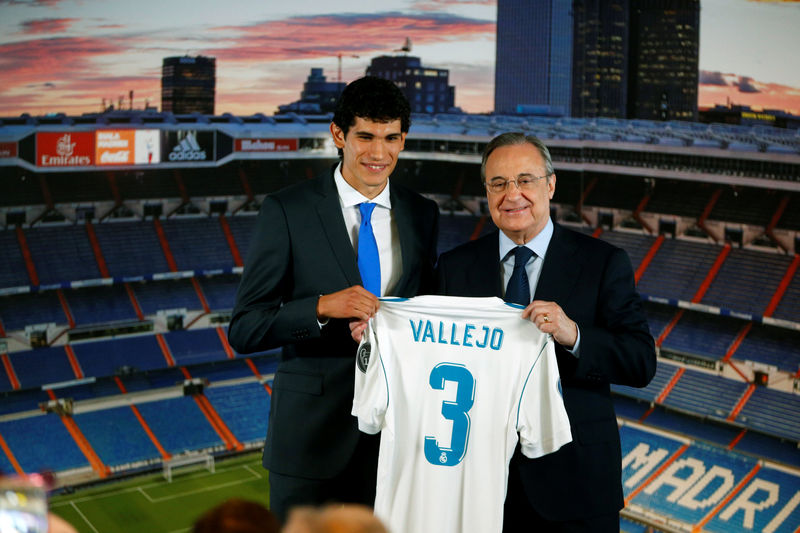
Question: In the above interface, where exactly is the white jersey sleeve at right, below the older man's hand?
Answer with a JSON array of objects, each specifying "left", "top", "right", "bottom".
[{"left": 517, "top": 337, "right": 572, "bottom": 459}]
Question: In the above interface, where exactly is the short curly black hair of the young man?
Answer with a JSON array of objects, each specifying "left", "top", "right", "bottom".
[{"left": 333, "top": 76, "right": 411, "bottom": 135}]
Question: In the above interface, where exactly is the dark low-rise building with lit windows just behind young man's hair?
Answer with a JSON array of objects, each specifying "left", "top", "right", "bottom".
[{"left": 367, "top": 55, "right": 456, "bottom": 113}]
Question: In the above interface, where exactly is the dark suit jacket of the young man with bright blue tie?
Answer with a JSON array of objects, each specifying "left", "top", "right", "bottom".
[{"left": 228, "top": 168, "right": 439, "bottom": 479}]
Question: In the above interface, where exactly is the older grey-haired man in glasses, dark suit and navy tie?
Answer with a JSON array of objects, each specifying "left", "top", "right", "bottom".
[{"left": 437, "top": 133, "right": 656, "bottom": 533}]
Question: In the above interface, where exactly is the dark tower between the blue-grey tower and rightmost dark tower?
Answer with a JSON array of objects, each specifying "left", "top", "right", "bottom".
[{"left": 572, "top": 0, "right": 630, "bottom": 118}]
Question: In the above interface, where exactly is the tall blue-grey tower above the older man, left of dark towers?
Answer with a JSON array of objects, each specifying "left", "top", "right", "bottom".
[{"left": 494, "top": 0, "right": 573, "bottom": 115}]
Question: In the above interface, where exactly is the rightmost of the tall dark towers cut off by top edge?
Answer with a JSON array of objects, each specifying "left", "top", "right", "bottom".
[{"left": 628, "top": 0, "right": 700, "bottom": 121}]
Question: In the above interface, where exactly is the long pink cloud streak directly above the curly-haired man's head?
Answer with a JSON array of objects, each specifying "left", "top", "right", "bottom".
[{"left": 203, "top": 12, "right": 495, "bottom": 62}]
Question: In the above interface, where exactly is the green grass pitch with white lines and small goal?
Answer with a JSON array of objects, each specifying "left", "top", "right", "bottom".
[{"left": 50, "top": 453, "right": 269, "bottom": 533}]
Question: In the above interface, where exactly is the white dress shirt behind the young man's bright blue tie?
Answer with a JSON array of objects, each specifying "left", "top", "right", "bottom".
[{"left": 333, "top": 163, "right": 403, "bottom": 296}]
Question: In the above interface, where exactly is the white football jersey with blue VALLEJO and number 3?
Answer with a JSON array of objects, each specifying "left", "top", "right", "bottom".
[{"left": 352, "top": 296, "right": 572, "bottom": 533}]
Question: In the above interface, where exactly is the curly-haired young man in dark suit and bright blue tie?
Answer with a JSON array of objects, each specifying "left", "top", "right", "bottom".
[{"left": 228, "top": 77, "right": 439, "bottom": 521}]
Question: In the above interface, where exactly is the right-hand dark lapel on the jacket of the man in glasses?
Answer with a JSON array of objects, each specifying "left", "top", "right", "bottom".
[{"left": 534, "top": 224, "right": 581, "bottom": 302}]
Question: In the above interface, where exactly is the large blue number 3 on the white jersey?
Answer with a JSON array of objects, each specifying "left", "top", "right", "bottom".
[{"left": 425, "top": 363, "right": 475, "bottom": 466}]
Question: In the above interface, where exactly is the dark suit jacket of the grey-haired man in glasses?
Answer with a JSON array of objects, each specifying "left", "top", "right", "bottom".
[{"left": 437, "top": 224, "right": 656, "bottom": 521}]
